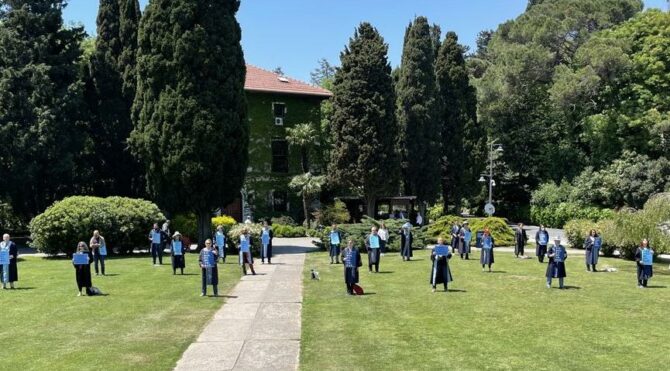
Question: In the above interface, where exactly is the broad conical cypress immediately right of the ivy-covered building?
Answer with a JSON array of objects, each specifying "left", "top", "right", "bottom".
[{"left": 329, "top": 23, "right": 399, "bottom": 216}]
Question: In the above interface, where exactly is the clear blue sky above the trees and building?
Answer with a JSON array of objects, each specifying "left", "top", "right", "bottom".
[{"left": 63, "top": 0, "right": 667, "bottom": 81}]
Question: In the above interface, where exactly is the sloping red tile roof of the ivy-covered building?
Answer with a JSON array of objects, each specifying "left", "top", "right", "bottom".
[{"left": 244, "top": 64, "right": 333, "bottom": 98}]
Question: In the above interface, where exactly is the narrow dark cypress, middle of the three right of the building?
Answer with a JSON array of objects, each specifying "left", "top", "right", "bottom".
[{"left": 396, "top": 17, "right": 440, "bottom": 214}]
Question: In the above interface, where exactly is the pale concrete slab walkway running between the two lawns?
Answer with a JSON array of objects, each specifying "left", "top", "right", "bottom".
[{"left": 175, "top": 238, "right": 313, "bottom": 370}]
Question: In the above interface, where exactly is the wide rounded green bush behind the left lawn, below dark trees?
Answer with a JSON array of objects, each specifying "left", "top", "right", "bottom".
[{"left": 29, "top": 196, "right": 165, "bottom": 255}]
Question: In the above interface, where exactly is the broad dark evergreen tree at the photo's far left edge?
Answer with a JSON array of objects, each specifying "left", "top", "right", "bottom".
[{"left": 0, "top": 0, "right": 88, "bottom": 217}]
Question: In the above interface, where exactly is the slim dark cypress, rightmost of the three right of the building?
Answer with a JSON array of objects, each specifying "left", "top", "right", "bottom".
[{"left": 435, "top": 32, "right": 486, "bottom": 214}]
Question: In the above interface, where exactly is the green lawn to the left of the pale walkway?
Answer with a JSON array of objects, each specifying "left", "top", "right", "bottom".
[{"left": 0, "top": 254, "right": 240, "bottom": 370}]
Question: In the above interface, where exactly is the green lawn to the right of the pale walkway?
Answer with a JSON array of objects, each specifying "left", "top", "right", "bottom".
[{"left": 300, "top": 251, "right": 670, "bottom": 370}]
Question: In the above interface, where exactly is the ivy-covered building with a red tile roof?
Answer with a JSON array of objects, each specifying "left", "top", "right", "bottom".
[{"left": 224, "top": 65, "right": 332, "bottom": 221}]
